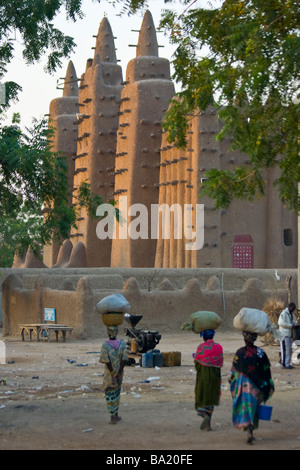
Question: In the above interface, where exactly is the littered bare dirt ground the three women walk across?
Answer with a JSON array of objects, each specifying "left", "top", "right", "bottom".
[{"left": 0, "top": 329, "right": 300, "bottom": 453}]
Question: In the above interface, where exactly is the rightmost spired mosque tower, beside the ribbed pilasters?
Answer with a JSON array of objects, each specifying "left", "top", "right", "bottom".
[{"left": 112, "top": 11, "right": 175, "bottom": 267}]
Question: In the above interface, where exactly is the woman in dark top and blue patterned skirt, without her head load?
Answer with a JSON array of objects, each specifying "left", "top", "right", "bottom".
[{"left": 229, "top": 331, "right": 274, "bottom": 444}]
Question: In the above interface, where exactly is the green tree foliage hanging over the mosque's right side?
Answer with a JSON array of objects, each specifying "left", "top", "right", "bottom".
[{"left": 121, "top": 0, "right": 300, "bottom": 212}]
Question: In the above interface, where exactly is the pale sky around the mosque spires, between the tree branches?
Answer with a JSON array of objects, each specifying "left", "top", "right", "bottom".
[{"left": 3, "top": 0, "right": 188, "bottom": 127}]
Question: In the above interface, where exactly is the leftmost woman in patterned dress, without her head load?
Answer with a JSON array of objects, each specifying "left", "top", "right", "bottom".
[{"left": 100, "top": 326, "right": 128, "bottom": 424}]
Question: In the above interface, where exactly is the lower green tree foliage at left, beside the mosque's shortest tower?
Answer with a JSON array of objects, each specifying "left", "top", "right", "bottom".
[{"left": 0, "top": 115, "right": 103, "bottom": 266}]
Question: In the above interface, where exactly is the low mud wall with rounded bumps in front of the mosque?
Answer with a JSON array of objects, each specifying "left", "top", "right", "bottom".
[{"left": 0, "top": 268, "right": 297, "bottom": 339}]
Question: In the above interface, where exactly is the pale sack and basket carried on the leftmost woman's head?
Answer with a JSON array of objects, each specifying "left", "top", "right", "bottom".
[{"left": 96, "top": 294, "right": 130, "bottom": 326}]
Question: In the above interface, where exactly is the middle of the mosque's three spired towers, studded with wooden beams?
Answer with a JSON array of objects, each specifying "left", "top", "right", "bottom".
[{"left": 71, "top": 17, "right": 123, "bottom": 267}]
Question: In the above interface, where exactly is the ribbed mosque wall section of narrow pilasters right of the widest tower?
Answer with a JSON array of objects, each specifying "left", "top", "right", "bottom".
[{"left": 155, "top": 104, "right": 198, "bottom": 268}]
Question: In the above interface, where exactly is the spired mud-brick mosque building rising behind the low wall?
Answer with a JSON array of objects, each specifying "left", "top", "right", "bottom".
[{"left": 14, "top": 11, "right": 297, "bottom": 269}]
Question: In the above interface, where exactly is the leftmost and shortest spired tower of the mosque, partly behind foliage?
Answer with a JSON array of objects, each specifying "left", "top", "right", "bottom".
[{"left": 43, "top": 61, "right": 79, "bottom": 267}]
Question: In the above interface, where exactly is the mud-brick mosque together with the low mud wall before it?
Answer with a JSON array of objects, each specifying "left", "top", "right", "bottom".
[{"left": 0, "top": 11, "right": 297, "bottom": 339}]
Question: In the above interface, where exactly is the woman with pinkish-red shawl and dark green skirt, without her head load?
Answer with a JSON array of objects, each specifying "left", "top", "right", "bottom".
[{"left": 194, "top": 330, "right": 223, "bottom": 431}]
